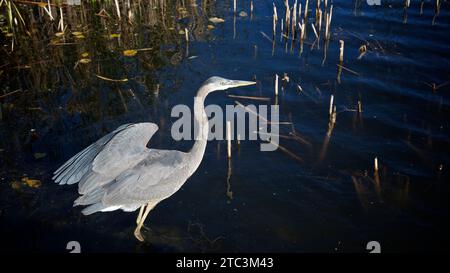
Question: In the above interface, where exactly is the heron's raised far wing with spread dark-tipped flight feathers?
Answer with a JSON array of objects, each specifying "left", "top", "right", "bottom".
[{"left": 53, "top": 123, "right": 158, "bottom": 193}]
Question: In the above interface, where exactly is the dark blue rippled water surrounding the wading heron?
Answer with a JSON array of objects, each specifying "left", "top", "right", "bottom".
[{"left": 0, "top": 1, "right": 450, "bottom": 252}]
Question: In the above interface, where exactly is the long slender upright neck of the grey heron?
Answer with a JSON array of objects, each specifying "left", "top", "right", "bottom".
[{"left": 189, "top": 87, "right": 209, "bottom": 174}]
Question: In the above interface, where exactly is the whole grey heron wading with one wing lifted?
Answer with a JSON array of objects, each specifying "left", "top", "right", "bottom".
[{"left": 53, "top": 77, "right": 255, "bottom": 241}]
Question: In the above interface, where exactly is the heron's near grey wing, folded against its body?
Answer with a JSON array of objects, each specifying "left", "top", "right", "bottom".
[{"left": 102, "top": 149, "right": 189, "bottom": 206}]
